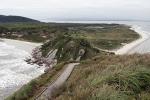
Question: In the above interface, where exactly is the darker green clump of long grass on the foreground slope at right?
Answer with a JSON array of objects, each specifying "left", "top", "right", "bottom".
[{"left": 107, "top": 68, "right": 150, "bottom": 94}]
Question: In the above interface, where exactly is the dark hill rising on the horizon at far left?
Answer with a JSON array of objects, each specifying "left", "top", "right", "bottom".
[{"left": 0, "top": 15, "right": 39, "bottom": 23}]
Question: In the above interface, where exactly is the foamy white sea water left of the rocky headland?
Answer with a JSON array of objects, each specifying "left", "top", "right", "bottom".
[{"left": 0, "top": 42, "right": 44, "bottom": 100}]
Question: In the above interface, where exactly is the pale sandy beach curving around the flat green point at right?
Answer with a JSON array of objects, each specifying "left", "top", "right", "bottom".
[{"left": 114, "top": 25, "right": 150, "bottom": 55}]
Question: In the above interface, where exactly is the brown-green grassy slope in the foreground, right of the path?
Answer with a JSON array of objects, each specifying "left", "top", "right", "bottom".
[{"left": 56, "top": 55, "right": 150, "bottom": 100}]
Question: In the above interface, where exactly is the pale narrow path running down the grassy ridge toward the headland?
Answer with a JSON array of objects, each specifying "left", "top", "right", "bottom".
[{"left": 36, "top": 63, "right": 79, "bottom": 100}]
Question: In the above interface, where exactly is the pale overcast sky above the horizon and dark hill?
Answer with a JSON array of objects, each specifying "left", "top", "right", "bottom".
[{"left": 0, "top": 0, "right": 150, "bottom": 21}]
